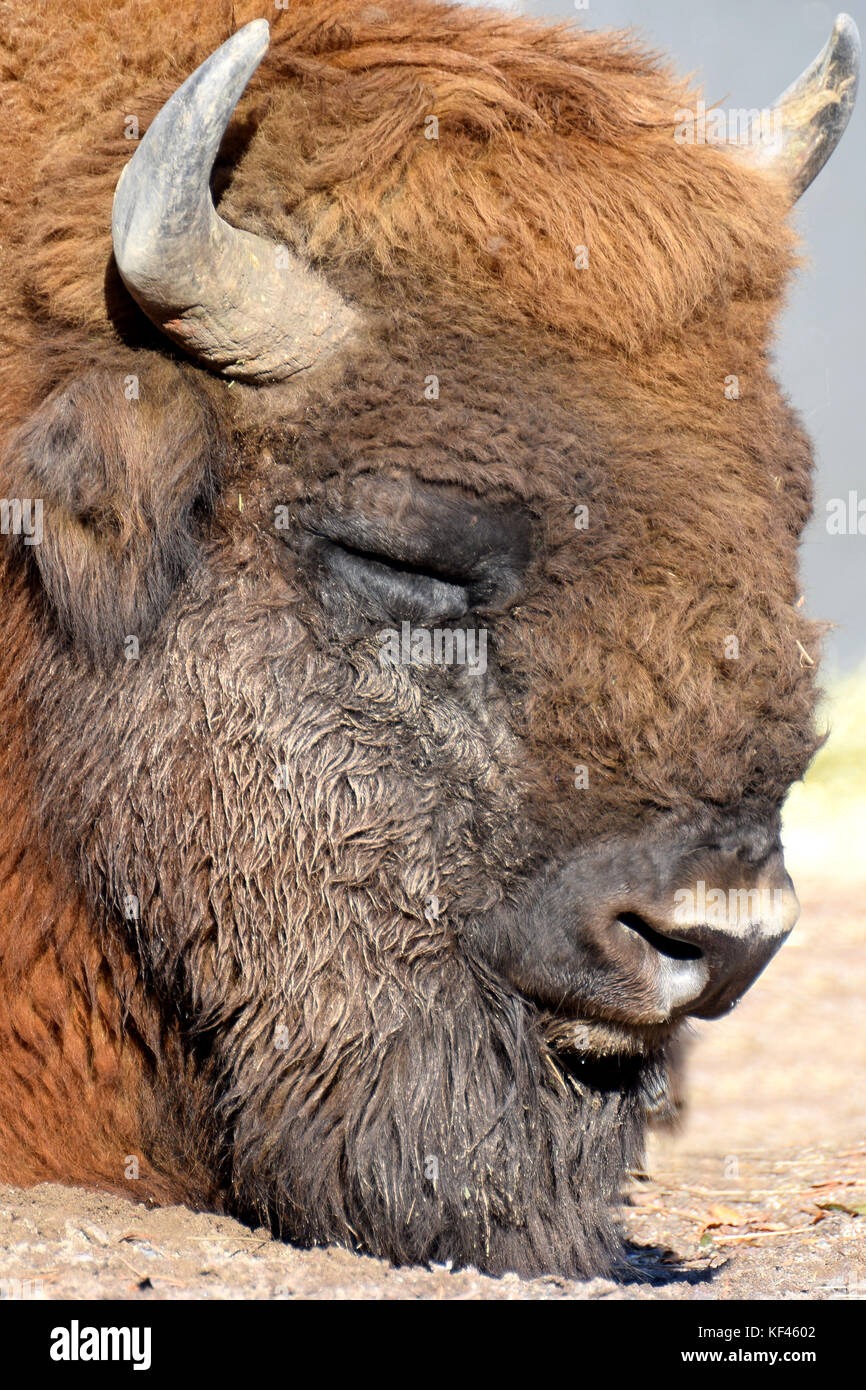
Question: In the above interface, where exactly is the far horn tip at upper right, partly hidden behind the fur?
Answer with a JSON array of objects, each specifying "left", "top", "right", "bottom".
[{"left": 742, "top": 14, "right": 860, "bottom": 203}]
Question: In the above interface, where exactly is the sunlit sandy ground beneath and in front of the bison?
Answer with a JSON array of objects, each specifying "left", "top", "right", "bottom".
[{"left": 0, "top": 885, "right": 866, "bottom": 1300}]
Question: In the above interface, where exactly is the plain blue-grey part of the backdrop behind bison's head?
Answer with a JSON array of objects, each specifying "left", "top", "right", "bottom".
[{"left": 487, "top": 0, "right": 866, "bottom": 676}]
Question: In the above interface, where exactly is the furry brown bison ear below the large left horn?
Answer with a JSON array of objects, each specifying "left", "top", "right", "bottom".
[{"left": 6, "top": 360, "right": 225, "bottom": 663}]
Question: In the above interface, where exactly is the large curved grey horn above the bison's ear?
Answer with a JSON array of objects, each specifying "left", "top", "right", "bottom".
[{"left": 111, "top": 19, "right": 354, "bottom": 381}]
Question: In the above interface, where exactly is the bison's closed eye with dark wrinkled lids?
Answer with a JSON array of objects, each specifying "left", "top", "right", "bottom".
[{"left": 299, "top": 474, "right": 530, "bottom": 626}]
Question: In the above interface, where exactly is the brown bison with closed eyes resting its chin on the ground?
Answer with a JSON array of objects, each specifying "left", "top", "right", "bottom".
[{"left": 0, "top": 0, "right": 859, "bottom": 1275}]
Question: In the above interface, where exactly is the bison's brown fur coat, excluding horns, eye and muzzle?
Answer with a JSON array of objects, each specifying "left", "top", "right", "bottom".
[{"left": 0, "top": 0, "right": 816, "bottom": 1269}]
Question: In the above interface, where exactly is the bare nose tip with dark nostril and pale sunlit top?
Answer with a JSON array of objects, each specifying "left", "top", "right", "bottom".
[{"left": 612, "top": 865, "right": 799, "bottom": 1019}]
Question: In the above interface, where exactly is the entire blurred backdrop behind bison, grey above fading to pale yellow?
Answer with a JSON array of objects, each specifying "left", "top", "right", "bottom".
[{"left": 475, "top": 0, "right": 866, "bottom": 889}]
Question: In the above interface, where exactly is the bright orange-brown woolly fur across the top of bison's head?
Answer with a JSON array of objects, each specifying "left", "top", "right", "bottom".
[{"left": 0, "top": 0, "right": 791, "bottom": 414}]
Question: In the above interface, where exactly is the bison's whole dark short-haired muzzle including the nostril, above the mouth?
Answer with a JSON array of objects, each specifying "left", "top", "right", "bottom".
[{"left": 463, "top": 820, "right": 799, "bottom": 1027}]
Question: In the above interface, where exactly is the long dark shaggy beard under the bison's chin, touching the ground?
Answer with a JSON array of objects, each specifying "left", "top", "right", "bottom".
[{"left": 221, "top": 956, "right": 666, "bottom": 1277}]
